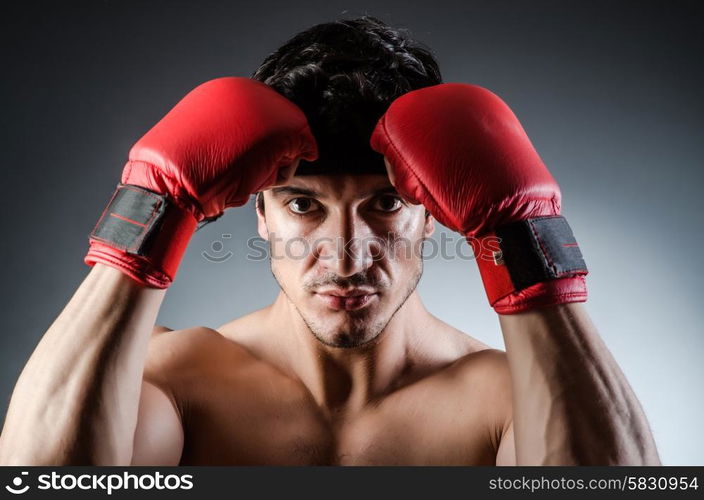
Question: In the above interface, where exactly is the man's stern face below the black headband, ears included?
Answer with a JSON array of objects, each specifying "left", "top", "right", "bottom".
[{"left": 258, "top": 175, "right": 434, "bottom": 347}]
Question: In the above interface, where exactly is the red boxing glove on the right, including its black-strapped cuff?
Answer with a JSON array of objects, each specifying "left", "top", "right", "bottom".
[{"left": 371, "top": 83, "right": 587, "bottom": 314}]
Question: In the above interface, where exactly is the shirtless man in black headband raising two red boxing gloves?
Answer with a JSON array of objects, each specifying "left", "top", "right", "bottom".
[{"left": 0, "top": 17, "right": 659, "bottom": 465}]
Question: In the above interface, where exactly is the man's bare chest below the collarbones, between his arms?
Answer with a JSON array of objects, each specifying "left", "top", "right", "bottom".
[{"left": 175, "top": 372, "right": 496, "bottom": 465}]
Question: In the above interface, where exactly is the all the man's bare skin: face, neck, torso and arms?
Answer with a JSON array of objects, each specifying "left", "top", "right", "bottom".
[{"left": 0, "top": 175, "right": 659, "bottom": 465}]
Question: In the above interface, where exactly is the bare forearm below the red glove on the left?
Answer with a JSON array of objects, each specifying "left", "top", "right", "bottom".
[{"left": 0, "top": 264, "right": 165, "bottom": 465}]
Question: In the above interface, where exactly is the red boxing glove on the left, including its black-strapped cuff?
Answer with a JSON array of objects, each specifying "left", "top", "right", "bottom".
[{"left": 85, "top": 77, "right": 318, "bottom": 288}]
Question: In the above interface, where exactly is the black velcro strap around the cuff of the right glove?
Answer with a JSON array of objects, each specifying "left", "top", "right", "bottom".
[{"left": 495, "top": 216, "right": 587, "bottom": 290}]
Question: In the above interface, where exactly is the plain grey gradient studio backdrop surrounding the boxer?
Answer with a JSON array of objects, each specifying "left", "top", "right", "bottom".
[{"left": 0, "top": 0, "right": 704, "bottom": 465}]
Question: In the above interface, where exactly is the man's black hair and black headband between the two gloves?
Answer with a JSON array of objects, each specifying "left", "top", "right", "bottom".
[{"left": 252, "top": 16, "right": 442, "bottom": 184}]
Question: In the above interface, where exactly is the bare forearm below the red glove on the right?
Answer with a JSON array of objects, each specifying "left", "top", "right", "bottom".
[{"left": 499, "top": 303, "right": 659, "bottom": 465}]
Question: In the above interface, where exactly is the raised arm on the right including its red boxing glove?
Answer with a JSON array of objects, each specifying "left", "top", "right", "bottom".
[{"left": 371, "top": 83, "right": 658, "bottom": 465}]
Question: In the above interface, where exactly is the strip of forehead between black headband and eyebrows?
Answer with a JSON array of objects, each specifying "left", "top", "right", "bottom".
[{"left": 270, "top": 174, "right": 395, "bottom": 199}]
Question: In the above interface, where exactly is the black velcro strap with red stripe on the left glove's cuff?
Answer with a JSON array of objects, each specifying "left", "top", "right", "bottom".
[{"left": 90, "top": 184, "right": 169, "bottom": 255}]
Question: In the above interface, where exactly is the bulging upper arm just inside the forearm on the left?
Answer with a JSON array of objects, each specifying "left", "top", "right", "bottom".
[{"left": 132, "top": 381, "right": 183, "bottom": 465}]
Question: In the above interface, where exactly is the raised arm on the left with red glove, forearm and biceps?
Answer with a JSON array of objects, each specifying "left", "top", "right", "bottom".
[{"left": 0, "top": 77, "right": 317, "bottom": 465}]
